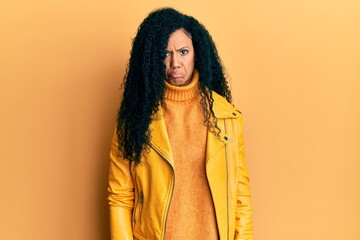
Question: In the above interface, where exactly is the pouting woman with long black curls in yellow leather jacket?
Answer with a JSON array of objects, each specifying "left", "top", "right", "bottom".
[{"left": 108, "top": 8, "right": 253, "bottom": 240}]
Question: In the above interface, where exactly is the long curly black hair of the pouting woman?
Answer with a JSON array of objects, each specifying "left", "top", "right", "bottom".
[{"left": 116, "top": 8, "right": 231, "bottom": 164}]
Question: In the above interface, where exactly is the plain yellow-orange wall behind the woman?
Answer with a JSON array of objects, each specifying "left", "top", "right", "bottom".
[{"left": 0, "top": 0, "right": 360, "bottom": 240}]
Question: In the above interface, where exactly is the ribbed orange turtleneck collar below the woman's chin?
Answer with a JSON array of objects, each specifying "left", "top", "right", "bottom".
[{"left": 164, "top": 69, "right": 200, "bottom": 104}]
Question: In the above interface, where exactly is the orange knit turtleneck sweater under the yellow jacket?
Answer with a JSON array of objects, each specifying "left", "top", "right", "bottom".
[{"left": 162, "top": 71, "right": 218, "bottom": 240}]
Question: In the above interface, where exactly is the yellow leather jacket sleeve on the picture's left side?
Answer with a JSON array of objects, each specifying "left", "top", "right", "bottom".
[{"left": 108, "top": 128, "right": 134, "bottom": 240}]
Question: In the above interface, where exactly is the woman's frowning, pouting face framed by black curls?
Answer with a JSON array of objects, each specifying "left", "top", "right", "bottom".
[{"left": 165, "top": 29, "right": 195, "bottom": 86}]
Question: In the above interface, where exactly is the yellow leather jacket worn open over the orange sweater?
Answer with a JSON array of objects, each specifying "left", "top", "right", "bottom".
[{"left": 108, "top": 92, "right": 253, "bottom": 240}]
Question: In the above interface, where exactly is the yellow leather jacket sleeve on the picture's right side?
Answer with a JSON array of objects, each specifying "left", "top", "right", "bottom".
[{"left": 235, "top": 116, "right": 254, "bottom": 240}]
